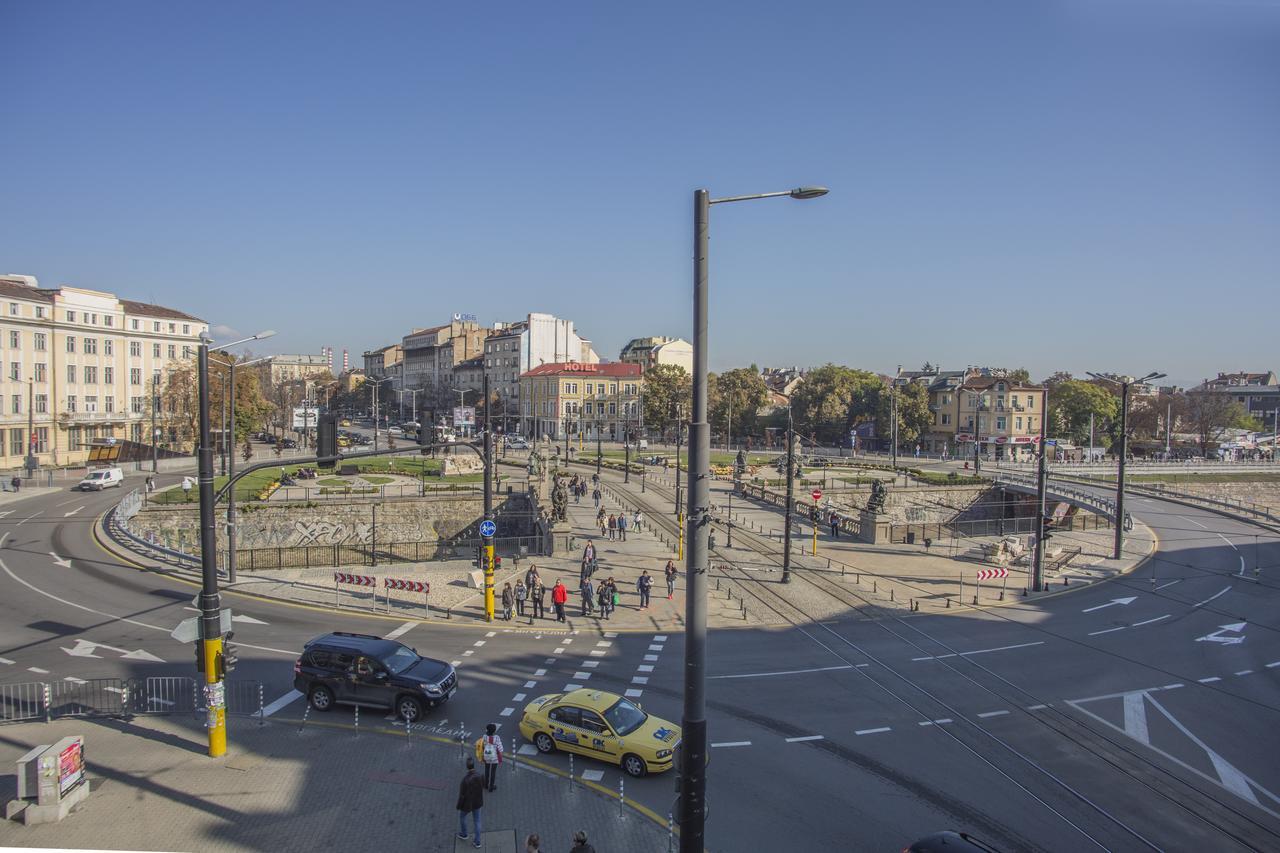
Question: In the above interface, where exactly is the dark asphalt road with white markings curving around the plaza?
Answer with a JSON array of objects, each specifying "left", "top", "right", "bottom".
[{"left": 0, "top": 468, "right": 1280, "bottom": 850}]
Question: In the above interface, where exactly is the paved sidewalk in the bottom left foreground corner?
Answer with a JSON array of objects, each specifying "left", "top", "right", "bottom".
[{"left": 0, "top": 716, "right": 668, "bottom": 853}]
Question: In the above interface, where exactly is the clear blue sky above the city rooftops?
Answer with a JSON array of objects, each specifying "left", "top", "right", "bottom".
[{"left": 0, "top": 0, "right": 1280, "bottom": 383}]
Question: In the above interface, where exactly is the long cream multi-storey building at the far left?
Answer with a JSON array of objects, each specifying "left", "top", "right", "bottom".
[{"left": 0, "top": 274, "right": 209, "bottom": 469}]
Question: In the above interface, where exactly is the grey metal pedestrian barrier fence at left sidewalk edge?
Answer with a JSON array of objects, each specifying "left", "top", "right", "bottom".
[{"left": 0, "top": 676, "right": 262, "bottom": 724}]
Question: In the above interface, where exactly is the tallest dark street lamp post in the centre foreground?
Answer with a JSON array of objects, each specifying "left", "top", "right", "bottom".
[{"left": 676, "top": 187, "right": 827, "bottom": 853}]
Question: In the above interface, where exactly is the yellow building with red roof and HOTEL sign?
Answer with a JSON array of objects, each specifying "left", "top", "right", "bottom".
[{"left": 520, "top": 361, "right": 644, "bottom": 441}]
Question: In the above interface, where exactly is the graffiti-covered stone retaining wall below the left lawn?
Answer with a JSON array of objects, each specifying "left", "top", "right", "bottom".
[{"left": 131, "top": 493, "right": 535, "bottom": 552}]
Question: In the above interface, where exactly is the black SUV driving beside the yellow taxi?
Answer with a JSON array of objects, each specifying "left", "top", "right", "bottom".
[{"left": 293, "top": 631, "right": 458, "bottom": 722}]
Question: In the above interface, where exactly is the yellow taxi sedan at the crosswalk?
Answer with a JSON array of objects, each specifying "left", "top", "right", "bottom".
[{"left": 520, "top": 689, "right": 681, "bottom": 776}]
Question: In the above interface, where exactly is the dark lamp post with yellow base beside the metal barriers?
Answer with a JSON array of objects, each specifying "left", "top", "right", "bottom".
[{"left": 197, "top": 332, "right": 275, "bottom": 758}]
